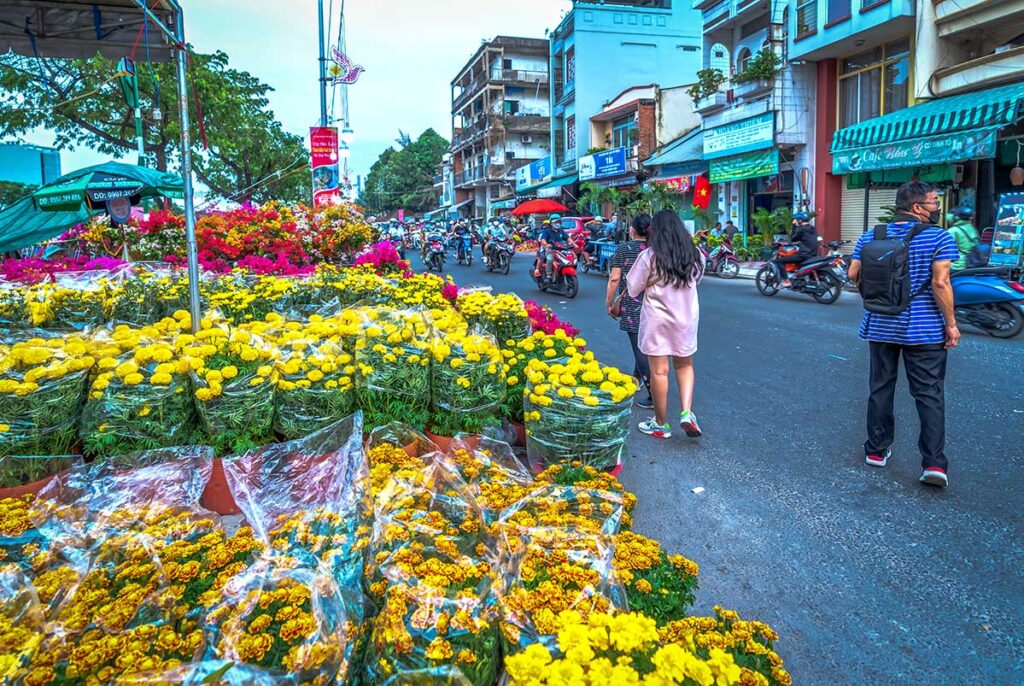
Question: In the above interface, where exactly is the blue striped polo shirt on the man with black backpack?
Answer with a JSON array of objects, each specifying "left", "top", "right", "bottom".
[{"left": 853, "top": 221, "right": 959, "bottom": 345}]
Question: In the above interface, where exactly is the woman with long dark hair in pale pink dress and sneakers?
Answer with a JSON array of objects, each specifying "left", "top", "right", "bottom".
[{"left": 627, "top": 210, "right": 703, "bottom": 438}]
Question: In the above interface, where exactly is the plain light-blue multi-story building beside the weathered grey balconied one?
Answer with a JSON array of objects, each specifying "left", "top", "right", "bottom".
[{"left": 551, "top": 0, "right": 700, "bottom": 189}]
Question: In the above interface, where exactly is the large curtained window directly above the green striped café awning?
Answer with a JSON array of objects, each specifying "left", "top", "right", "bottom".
[{"left": 839, "top": 39, "right": 910, "bottom": 127}]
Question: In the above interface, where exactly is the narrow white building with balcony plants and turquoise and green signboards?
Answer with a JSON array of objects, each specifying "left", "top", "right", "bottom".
[{"left": 693, "top": 0, "right": 814, "bottom": 232}]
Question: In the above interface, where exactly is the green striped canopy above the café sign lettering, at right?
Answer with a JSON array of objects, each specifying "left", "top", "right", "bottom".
[{"left": 831, "top": 83, "right": 1024, "bottom": 153}]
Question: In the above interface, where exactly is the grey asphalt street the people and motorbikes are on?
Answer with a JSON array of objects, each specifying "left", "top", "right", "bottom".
[{"left": 416, "top": 247, "right": 1024, "bottom": 684}]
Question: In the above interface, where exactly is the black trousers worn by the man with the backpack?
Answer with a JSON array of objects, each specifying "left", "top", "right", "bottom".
[{"left": 864, "top": 341, "right": 948, "bottom": 469}]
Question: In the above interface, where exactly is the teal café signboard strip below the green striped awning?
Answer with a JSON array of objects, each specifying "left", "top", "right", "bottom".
[{"left": 833, "top": 129, "right": 996, "bottom": 174}]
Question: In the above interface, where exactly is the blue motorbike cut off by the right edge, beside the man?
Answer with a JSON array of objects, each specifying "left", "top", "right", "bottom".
[{"left": 951, "top": 267, "right": 1024, "bottom": 338}]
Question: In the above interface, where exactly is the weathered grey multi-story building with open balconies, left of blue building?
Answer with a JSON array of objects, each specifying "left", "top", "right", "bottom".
[{"left": 452, "top": 36, "right": 551, "bottom": 217}]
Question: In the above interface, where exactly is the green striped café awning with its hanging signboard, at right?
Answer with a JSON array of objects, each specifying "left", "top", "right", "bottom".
[{"left": 831, "top": 84, "right": 1024, "bottom": 174}]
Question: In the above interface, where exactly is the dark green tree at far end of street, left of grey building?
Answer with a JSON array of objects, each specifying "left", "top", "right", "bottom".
[{"left": 359, "top": 129, "right": 449, "bottom": 214}]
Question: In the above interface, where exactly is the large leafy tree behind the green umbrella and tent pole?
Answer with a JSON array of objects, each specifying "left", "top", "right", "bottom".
[{"left": 0, "top": 50, "right": 309, "bottom": 202}]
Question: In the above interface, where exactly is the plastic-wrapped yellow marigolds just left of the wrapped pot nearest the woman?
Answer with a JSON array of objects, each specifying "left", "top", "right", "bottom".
[{"left": 430, "top": 329, "right": 505, "bottom": 436}]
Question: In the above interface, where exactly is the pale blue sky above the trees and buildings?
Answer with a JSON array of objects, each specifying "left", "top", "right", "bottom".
[{"left": 18, "top": 0, "right": 571, "bottom": 198}]
